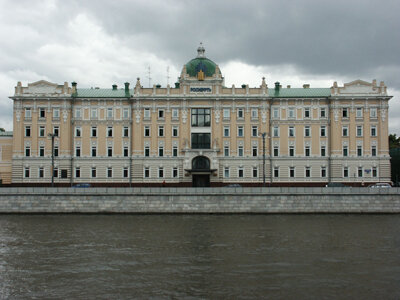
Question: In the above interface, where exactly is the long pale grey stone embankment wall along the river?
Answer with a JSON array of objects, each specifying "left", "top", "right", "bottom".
[{"left": 0, "top": 187, "right": 400, "bottom": 213}]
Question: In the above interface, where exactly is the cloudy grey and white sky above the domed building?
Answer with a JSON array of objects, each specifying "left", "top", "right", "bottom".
[{"left": 0, "top": 0, "right": 400, "bottom": 135}]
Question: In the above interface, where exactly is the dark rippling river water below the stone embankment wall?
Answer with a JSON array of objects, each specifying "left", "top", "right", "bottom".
[{"left": 0, "top": 215, "right": 400, "bottom": 299}]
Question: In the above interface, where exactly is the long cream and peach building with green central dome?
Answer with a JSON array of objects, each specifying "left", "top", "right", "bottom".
[{"left": 0, "top": 46, "right": 391, "bottom": 186}]
